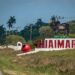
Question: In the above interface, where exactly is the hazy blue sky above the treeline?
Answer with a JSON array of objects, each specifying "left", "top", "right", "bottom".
[{"left": 0, "top": 0, "right": 75, "bottom": 29}]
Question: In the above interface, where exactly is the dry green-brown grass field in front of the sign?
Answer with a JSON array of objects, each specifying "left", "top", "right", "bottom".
[{"left": 0, "top": 49, "right": 75, "bottom": 75}]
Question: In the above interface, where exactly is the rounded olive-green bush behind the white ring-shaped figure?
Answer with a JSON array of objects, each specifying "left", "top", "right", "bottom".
[{"left": 6, "top": 35, "right": 26, "bottom": 45}]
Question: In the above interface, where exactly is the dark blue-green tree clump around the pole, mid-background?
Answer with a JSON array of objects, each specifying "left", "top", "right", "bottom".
[{"left": 20, "top": 19, "right": 48, "bottom": 41}]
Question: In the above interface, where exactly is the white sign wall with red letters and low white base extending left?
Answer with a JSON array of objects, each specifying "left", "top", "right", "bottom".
[{"left": 17, "top": 38, "right": 75, "bottom": 56}]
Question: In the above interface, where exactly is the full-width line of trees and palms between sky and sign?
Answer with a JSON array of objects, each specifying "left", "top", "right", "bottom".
[{"left": 0, "top": 16, "right": 75, "bottom": 45}]
